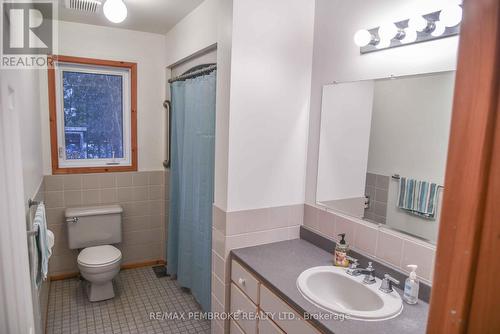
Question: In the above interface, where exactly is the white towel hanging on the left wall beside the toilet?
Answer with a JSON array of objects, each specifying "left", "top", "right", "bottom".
[{"left": 33, "top": 203, "right": 54, "bottom": 284}]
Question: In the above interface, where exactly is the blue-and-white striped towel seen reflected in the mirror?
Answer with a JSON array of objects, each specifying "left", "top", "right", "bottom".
[{"left": 398, "top": 177, "right": 438, "bottom": 219}]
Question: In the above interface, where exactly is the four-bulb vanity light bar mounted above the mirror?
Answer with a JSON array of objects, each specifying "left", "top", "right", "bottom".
[{"left": 354, "top": 4, "right": 462, "bottom": 54}]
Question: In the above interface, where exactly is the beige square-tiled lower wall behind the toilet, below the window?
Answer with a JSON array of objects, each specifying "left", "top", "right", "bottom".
[{"left": 44, "top": 171, "right": 169, "bottom": 275}]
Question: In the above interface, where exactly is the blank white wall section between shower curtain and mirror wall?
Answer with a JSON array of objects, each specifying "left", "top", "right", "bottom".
[{"left": 227, "top": 0, "right": 314, "bottom": 211}]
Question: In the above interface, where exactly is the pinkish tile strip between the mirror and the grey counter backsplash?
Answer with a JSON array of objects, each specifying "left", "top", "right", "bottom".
[{"left": 304, "top": 205, "right": 436, "bottom": 285}]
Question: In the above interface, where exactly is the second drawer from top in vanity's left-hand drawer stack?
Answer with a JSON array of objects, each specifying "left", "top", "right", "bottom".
[{"left": 231, "top": 283, "right": 257, "bottom": 334}]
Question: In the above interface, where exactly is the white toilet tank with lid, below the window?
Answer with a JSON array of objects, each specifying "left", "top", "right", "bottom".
[{"left": 66, "top": 205, "right": 123, "bottom": 249}]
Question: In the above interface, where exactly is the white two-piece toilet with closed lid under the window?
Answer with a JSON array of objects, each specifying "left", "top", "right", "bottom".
[{"left": 65, "top": 205, "right": 123, "bottom": 302}]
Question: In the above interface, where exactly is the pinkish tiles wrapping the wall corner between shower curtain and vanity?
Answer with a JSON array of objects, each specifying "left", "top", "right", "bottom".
[{"left": 212, "top": 204, "right": 304, "bottom": 333}]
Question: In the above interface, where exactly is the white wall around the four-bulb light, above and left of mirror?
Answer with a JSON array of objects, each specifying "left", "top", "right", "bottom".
[{"left": 306, "top": 0, "right": 458, "bottom": 204}]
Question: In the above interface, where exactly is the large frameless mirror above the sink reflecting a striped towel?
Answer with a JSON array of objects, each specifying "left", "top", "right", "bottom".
[{"left": 316, "top": 72, "right": 455, "bottom": 243}]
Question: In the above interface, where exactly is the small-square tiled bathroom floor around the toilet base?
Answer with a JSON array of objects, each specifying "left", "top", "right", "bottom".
[{"left": 47, "top": 267, "right": 210, "bottom": 334}]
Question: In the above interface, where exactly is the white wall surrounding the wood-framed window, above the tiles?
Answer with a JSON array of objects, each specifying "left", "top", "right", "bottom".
[{"left": 40, "top": 22, "right": 166, "bottom": 174}]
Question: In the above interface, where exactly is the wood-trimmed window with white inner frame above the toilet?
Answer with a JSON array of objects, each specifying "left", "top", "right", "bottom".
[{"left": 49, "top": 56, "right": 137, "bottom": 174}]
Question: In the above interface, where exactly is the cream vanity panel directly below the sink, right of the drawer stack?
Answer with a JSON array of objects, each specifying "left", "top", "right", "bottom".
[{"left": 260, "top": 285, "right": 320, "bottom": 334}]
